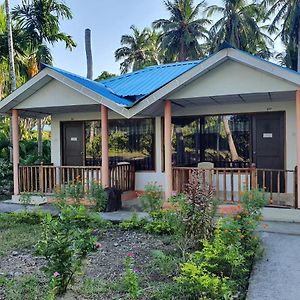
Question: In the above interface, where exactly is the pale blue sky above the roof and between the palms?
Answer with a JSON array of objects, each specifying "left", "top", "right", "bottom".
[{"left": 11, "top": 0, "right": 282, "bottom": 78}]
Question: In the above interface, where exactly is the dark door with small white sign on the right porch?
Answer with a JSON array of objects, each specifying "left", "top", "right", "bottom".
[{"left": 253, "top": 113, "right": 284, "bottom": 192}]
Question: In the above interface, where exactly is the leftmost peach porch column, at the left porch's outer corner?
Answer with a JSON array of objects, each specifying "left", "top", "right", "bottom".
[{"left": 11, "top": 109, "right": 20, "bottom": 195}]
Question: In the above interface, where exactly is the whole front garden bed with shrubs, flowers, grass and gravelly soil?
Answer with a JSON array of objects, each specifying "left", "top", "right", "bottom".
[{"left": 0, "top": 173, "right": 265, "bottom": 300}]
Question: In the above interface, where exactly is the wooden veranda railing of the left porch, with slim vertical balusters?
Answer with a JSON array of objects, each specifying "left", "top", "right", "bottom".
[{"left": 19, "top": 164, "right": 135, "bottom": 194}]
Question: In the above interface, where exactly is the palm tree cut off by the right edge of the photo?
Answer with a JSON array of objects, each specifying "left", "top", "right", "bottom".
[{"left": 262, "top": 0, "right": 300, "bottom": 72}]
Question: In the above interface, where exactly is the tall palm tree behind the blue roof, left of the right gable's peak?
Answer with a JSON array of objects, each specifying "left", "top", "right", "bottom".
[{"left": 153, "top": 0, "right": 210, "bottom": 61}]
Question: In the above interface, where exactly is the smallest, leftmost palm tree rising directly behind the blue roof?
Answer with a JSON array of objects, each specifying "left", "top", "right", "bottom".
[{"left": 115, "top": 25, "right": 157, "bottom": 74}]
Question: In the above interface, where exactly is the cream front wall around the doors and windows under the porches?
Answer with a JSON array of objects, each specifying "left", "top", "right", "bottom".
[{"left": 51, "top": 101, "right": 296, "bottom": 190}]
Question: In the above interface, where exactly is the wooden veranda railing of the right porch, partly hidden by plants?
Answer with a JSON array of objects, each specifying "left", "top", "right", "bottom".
[{"left": 173, "top": 166, "right": 297, "bottom": 207}]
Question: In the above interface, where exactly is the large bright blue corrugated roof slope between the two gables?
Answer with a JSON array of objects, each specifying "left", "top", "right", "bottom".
[{"left": 101, "top": 60, "right": 201, "bottom": 99}]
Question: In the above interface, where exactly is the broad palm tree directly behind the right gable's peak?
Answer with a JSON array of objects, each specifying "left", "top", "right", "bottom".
[{"left": 206, "top": 0, "right": 272, "bottom": 58}]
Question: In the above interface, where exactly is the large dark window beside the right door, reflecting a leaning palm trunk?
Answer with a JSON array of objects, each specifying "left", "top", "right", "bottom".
[{"left": 172, "top": 114, "right": 250, "bottom": 167}]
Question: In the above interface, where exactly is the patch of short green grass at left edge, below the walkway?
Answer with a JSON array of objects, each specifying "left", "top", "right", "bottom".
[{"left": 0, "top": 214, "right": 41, "bottom": 257}]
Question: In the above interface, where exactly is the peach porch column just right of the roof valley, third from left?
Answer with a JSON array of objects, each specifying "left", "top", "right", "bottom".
[{"left": 165, "top": 100, "right": 173, "bottom": 200}]
